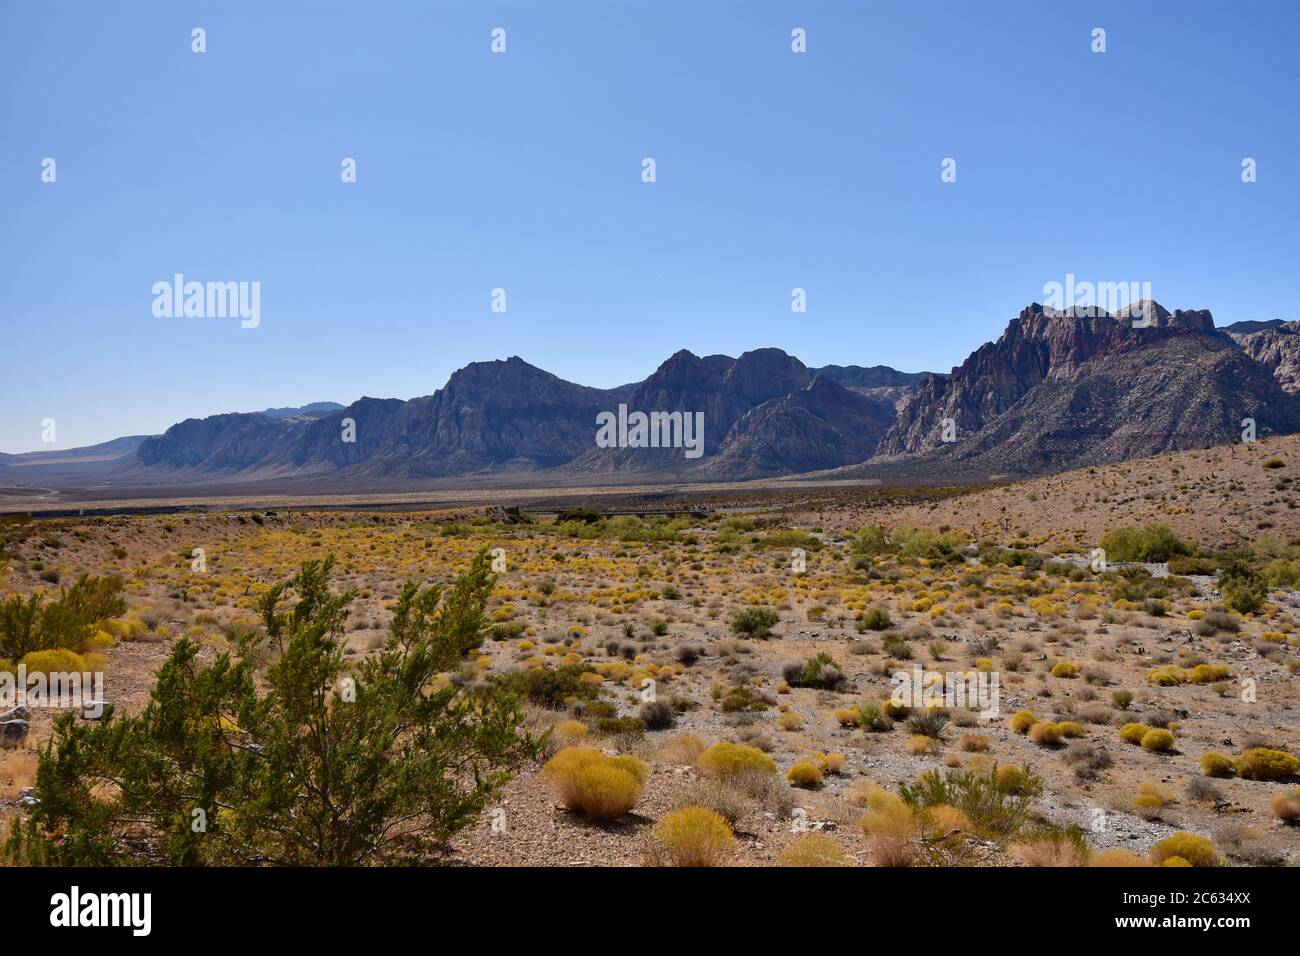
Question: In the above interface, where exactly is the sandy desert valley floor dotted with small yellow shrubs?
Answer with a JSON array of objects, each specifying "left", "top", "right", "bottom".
[{"left": 0, "top": 436, "right": 1300, "bottom": 866}]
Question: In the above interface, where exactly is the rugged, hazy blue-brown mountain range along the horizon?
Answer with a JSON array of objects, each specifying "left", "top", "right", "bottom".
[{"left": 10, "top": 302, "right": 1300, "bottom": 494}]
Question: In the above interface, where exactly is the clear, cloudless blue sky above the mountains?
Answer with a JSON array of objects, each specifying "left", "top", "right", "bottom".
[{"left": 0, "top": 0, "right": 1300, "bottom": 451}]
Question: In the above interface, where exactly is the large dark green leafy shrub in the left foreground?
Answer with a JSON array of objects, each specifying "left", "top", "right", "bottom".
[{"left": 8, "top": 553, "right": 538, "bottom": 866}]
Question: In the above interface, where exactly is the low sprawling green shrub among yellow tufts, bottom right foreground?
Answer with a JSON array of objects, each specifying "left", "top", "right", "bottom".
[{"left": 898, "top": 767, "right": 1043, "bottom": 839}]
